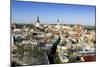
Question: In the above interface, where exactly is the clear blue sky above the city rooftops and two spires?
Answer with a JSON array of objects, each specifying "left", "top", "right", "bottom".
[{"left": 12, "top": 0, "right": 96, "bottom": 25}]
